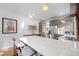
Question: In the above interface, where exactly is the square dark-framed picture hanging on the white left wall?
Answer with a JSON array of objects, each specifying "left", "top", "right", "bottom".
[{"left": 2, "top": 18, "right": 17, "bottom": 34}]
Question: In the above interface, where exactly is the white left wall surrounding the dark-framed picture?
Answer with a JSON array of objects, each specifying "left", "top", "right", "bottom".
[{"left": 0, "top": 13, "right": 26, "bottom": 49}]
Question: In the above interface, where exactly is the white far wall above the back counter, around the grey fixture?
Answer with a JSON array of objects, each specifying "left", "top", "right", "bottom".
[{"left": 23, "top": 18, "right": 39, "bottom": 35}]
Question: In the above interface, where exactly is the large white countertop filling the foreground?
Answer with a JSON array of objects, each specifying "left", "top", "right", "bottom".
[{"left": 20, "top": 36, "right": 79, "bottom": 56}]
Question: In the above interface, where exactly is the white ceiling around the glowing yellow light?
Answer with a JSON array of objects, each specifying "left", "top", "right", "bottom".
[{"left": 0, "top": 3, "right": 70, "bottom": 19}]
